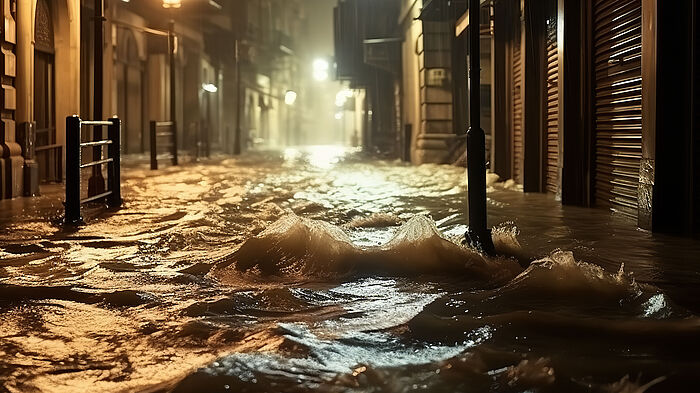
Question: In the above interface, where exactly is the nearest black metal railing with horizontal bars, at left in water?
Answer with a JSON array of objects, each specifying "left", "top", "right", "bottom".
[{"left": 65, "top": 116, "right": 122, "bottom": 225}]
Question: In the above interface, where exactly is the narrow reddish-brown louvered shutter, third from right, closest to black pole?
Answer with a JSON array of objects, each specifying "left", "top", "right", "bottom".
[{"left": 511, "top": 28, "right": 523, "bottom": 184}]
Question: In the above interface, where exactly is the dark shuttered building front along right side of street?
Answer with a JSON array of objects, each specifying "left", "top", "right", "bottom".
[{"left": 486, "top": 0, "right": 699, "bottom": 232}]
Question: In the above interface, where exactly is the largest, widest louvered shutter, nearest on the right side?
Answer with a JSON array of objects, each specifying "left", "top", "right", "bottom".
[{"left": 593, "top": 0, "right": 642, "bottom": 217}]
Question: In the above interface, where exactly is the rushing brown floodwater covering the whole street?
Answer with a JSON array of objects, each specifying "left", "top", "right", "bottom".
[{"left": 0, "top": 147, "right": 700, "bottom": 392}]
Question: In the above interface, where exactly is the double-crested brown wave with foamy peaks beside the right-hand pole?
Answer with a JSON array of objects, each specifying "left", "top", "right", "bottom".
[{"left": 212, "top": 214, "right": 520, "bottom": 282}]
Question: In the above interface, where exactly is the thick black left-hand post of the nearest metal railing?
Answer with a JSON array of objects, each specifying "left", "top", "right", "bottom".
[{"left": 65, "top": 116, "right": 83, "bottom": 225}]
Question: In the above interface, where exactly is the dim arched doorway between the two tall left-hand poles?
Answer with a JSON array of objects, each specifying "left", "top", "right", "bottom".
[{"left": 114, "top": 29, "right": 146, "bottom": 153}]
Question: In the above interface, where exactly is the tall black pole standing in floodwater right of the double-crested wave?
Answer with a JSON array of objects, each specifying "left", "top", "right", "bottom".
[{"left": 465, "top": 0, "right": 494, "bottom": 254}]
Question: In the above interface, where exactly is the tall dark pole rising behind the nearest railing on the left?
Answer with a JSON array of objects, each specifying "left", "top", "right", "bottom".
[{"left": 88, "top": 0, "right": 105, "bottom": 196}]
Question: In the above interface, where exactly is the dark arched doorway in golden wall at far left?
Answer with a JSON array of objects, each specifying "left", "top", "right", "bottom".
[{"left": 34, "top": 0, "right": 63, "bottom": 182}]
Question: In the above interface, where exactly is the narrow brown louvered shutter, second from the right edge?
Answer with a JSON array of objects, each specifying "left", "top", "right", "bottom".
[{"left": 543, "top": 19, "right": 559, "bottom": 194}]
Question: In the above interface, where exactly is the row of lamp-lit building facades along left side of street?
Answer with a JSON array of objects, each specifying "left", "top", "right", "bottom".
[{"left": 0, "top": 0, "right": 312, "bottom": 198}]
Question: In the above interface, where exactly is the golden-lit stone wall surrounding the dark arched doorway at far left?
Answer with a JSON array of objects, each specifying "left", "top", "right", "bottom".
[{"left": 0, "top": 0, "right": 80, "bottom": 198}]
